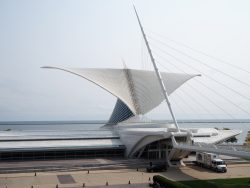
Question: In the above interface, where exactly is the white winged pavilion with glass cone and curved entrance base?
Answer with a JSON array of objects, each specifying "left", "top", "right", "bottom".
[{"left": 43, "top": 67, "right": 246, "bottom": 160}]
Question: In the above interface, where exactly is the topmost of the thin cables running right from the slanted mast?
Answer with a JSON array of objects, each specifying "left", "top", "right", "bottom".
[{"left": 146, "top": 28, "right": 250, "bottom": 74}]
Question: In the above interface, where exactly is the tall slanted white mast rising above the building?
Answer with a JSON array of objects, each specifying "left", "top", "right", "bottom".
[{"left": 133, "top": 5, "right": 180, "bottom": 132}]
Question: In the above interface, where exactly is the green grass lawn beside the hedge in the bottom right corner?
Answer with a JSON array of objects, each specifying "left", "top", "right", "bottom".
[{"left": 180, "top": 177, "right": 250, "bottom": 188}]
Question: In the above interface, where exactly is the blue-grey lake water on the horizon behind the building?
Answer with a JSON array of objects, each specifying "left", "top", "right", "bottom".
[{"left": 0, "top": 120, "right": 250, "bottom": 144}]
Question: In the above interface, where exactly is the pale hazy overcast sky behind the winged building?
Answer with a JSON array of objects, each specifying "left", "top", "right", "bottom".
[{"left": 0, "top": 0, "right": 250, "bottom": 121}]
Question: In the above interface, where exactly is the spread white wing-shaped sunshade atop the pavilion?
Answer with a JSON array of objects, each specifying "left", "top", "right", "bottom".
[{"left": 43, "top": 67, "right": 197, "bottom": 114}]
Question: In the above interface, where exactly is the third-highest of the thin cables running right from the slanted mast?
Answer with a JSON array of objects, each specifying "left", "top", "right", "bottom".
[{"left": 151, "top": 44, "right": 250, "bottom": 101}]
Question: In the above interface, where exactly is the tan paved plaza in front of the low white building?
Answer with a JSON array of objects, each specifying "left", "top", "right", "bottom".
[{"left": 0, "top": 164, "right": 250, "bottom": 188}]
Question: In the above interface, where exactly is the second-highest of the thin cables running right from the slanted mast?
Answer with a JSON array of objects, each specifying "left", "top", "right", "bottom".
[{"left": 149, "top": 36, "right": 250, "bottom": 87}]
